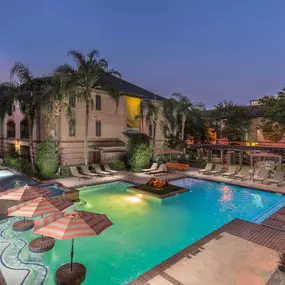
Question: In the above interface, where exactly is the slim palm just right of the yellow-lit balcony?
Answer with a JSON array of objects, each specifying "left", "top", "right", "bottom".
[{"left": 141, "top": 100, "right": 162, "bottom": 156}]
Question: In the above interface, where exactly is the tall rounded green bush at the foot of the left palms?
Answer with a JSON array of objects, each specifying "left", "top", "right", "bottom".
[{"left": 36, "top": 137, "right": 59, "bottom": 178}]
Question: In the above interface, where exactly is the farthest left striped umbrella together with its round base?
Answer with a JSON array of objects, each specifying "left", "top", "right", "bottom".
[{"left": 0, "top": 185, "right": 52, "bottom": 231}]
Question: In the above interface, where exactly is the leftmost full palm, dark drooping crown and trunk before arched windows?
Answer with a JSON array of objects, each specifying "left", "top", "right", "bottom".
[{"left": 9, "top": 62, "right": 41, "bottom": 172}]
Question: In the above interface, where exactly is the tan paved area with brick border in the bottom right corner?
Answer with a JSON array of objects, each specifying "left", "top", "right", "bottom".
[{"left": 129, "top": 201, "right": 285, "bottom": 285}]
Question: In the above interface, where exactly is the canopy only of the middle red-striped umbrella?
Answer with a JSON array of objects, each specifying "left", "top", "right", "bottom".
[{"left": 8, "top": 197, "right": 72, "bottom": 218}]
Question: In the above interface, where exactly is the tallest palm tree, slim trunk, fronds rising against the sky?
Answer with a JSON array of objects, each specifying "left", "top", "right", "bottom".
[{"left": 56, "top": 50, "right": 120, "bottom": 165}]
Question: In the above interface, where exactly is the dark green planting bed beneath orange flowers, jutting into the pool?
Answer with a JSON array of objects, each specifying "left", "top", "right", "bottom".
[{"left": 128, "top": 184, "right": 189, "bottom": 199}]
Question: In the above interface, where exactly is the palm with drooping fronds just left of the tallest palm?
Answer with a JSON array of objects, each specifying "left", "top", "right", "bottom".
[{"left": 42, "top": 74, "right": 74, "bottom": 147}]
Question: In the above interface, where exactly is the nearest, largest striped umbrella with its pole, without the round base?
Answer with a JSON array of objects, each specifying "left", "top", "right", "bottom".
[{"left": 34, "top": 210, "right": 113, "bottom": 271}]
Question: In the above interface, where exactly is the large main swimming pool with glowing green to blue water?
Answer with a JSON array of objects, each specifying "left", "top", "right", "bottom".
[{"left": 0, "top": 179, "right": 285, "bottom": 285}]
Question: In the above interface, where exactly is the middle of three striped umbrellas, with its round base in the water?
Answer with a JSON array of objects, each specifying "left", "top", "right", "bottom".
[{"left": 8, "top": 197, "right": 73, "bottom": 252}]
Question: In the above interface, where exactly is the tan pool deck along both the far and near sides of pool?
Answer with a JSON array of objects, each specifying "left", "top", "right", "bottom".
[{"left": 0, "top": 168, "right": 285, "bottom": 285}]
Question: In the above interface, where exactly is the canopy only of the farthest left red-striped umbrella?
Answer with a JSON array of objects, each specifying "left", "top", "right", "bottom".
[{"left": 0, "top": 185, "right": 52, "bottom": 202}]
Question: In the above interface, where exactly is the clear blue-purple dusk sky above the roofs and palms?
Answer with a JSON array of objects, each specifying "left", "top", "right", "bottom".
[{"left": 0, "top": 0, "right": 285, "bottom": 106}]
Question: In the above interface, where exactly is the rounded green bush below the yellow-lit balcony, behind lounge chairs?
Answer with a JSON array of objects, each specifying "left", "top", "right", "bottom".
[{"left": 129, "top": 143, "right": 152, "bottom": 172}]
